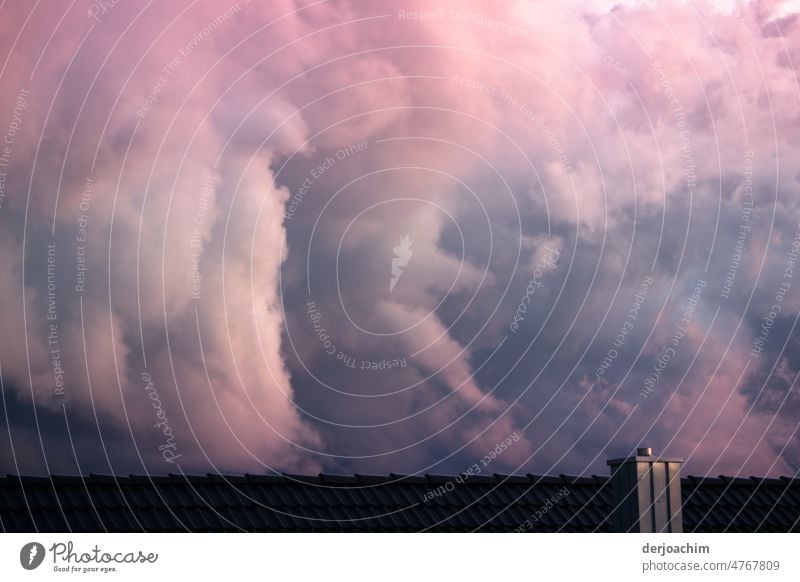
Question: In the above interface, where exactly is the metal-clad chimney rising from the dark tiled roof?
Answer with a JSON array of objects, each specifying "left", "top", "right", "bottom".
[{"left": 607, "top": 447, "right": 683, "bottom": 533}]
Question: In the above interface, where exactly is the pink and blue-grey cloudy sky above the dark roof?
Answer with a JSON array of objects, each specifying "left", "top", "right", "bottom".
[{"left": 0, "top": 0, "right": 800, "bottom": 476}]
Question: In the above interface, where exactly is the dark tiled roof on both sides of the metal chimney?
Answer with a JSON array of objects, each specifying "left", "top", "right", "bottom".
[{"left": 0, "top": 474, "right": 800, "bottom": 532}]
